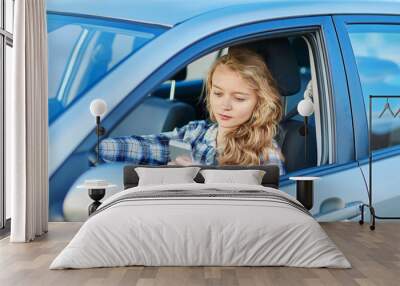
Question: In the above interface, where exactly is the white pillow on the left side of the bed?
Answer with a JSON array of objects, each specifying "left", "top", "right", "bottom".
[{"left": 135, "top": 167, "right": 200, "bottom": 186}]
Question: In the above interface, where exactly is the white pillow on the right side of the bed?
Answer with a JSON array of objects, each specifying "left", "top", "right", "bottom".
[{"left": 200, "top": 169, "right": 265, "bottom": 185}]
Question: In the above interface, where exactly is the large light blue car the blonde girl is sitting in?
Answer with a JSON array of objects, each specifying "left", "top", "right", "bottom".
[{"left": 47, "top": 0, "right": 400, "bottom": 221}]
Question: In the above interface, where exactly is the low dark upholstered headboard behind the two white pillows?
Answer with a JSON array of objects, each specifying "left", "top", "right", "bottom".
[{"left": 124, "top": 165, "right": 279, "bottom": 189}]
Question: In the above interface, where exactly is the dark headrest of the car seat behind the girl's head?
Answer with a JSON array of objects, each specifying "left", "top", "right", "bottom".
[{"left": 234, "top": 38, "right": 301, "bottom": 96}]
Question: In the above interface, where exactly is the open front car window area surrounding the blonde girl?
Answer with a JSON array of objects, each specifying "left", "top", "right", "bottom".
[{"left": 110, "top": 35, "right": 327, "bottom": 173}]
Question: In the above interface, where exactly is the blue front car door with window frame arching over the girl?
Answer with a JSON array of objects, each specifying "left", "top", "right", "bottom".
[{"left": 97, "top": 16, "right": 367, "bottom": 220}]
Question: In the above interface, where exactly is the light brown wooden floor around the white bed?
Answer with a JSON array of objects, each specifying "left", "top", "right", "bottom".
[{"left": 0, "top": 222, "right": 400, "bottom": 286}]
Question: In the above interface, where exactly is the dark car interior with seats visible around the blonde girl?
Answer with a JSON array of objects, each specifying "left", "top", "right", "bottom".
[{"left": 108, "top": 36, "right": 318, "bottom": 172}]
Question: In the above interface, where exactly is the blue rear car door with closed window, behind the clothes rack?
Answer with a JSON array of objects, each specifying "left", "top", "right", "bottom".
[{"left": 334, "top": 15, "right": 400, "bottom": 217}]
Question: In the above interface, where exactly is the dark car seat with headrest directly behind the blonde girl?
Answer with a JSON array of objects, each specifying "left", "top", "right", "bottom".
[{"left": 234, "top": 38, "right": 317, "bottom": 172}]
